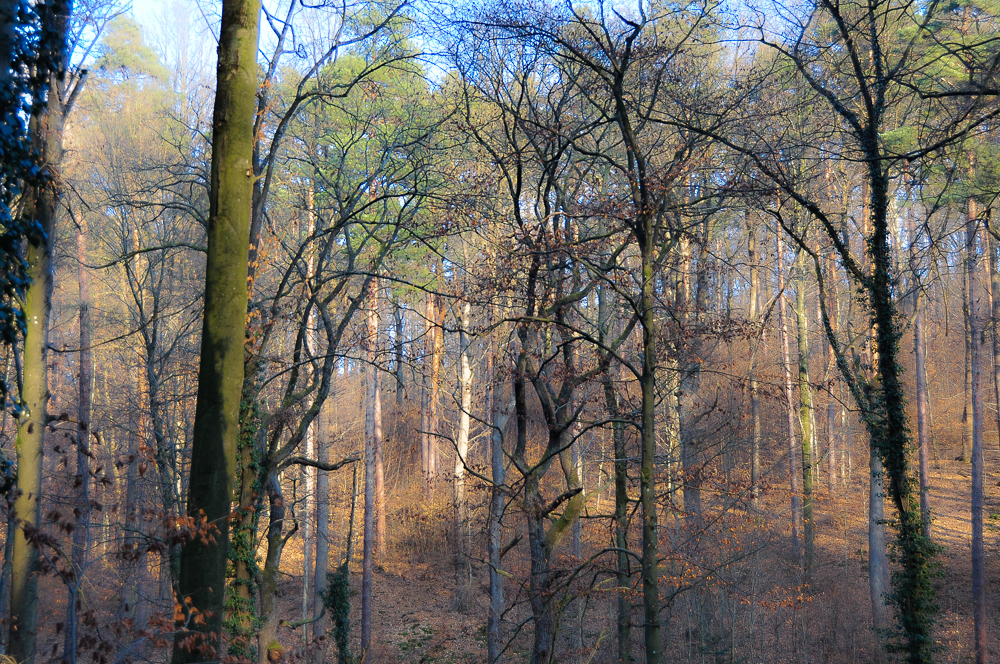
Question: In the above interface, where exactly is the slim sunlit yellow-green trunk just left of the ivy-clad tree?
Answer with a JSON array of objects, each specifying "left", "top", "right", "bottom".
[{"left": 795, "top": 253, "right": 816, "bottom": 573}]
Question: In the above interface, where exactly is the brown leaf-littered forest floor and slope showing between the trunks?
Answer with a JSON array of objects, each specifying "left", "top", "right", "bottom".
[{"left": 13, "top": 440, "right": 1000, "bottom": 664}]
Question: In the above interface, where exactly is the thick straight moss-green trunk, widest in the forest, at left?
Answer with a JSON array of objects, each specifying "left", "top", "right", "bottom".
[{"left": 173, "top": 0, "right": 260, "bottom": 664}]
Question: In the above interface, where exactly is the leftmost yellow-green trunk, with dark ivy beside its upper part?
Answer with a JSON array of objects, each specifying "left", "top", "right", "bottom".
[{"left": 7, "top": 0, "right": 73, "bottom": 664}]
